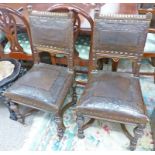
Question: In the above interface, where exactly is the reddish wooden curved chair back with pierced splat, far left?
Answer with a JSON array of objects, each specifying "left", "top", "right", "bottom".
[{"left": 0, "top": 5, "right": 33, "bottom": 60}]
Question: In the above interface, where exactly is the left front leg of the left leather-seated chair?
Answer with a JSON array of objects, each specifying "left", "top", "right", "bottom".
[{"left": 9, "top": 101, "right": 24, "bottom": 124}]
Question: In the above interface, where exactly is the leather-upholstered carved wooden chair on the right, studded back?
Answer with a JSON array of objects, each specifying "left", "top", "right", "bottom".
[{"left": 76, "top": 12, "right": 151, "bottom": 150}]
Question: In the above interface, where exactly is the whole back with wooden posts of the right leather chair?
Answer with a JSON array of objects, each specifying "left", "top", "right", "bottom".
[{"left": 90, "top": 11, "right": 151, "bottom": 76}]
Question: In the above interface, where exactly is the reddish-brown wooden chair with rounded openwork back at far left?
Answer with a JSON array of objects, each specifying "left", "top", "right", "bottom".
[{"left": 0, "top": 5, "right": 33, "bottom": 61}]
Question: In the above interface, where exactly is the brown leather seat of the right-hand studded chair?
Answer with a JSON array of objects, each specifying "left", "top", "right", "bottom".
[{"left": 77, "top": 71, "right": 148, "bottom": 123}]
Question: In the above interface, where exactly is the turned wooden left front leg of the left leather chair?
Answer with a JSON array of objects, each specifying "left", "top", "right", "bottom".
[{"left": 10, "top": 101, "right": 24, "bottom": 124}]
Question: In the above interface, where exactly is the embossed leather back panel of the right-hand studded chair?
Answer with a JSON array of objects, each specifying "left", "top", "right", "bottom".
[{"left": 93, "top": 15, "right": 150, "bottom": 58}]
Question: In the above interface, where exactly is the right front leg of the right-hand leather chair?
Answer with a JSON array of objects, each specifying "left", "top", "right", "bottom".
[{"left": 130, "top": 124, "right": 145, "bottom": 151}]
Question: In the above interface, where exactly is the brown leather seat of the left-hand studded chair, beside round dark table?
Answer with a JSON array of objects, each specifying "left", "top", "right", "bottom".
[{"left": 5, "top": 63, "right": 73, "bottom": 112}]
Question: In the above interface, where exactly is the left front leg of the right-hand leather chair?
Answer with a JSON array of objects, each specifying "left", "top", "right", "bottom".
[{"left": 77, "top": 115, "right": 85, "bottom": 139}]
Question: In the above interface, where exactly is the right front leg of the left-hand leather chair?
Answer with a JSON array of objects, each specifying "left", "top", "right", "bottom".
[{"left": 55, "top": 115, "right": 65, "bottom": 140}]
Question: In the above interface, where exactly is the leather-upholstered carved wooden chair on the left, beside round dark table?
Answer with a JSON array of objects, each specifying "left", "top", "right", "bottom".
[{"left": 5, "top": 7, "right": 75, "bottom": 138}]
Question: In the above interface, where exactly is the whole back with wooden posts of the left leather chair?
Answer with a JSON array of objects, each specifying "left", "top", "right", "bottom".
[{"left": 28, "top": 7, "right": 74, "bottom": 71}]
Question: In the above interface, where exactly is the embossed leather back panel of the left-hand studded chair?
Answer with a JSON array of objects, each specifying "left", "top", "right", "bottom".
[{"left": 29, "top": 11, "right": 73, "bottom": 50}]
